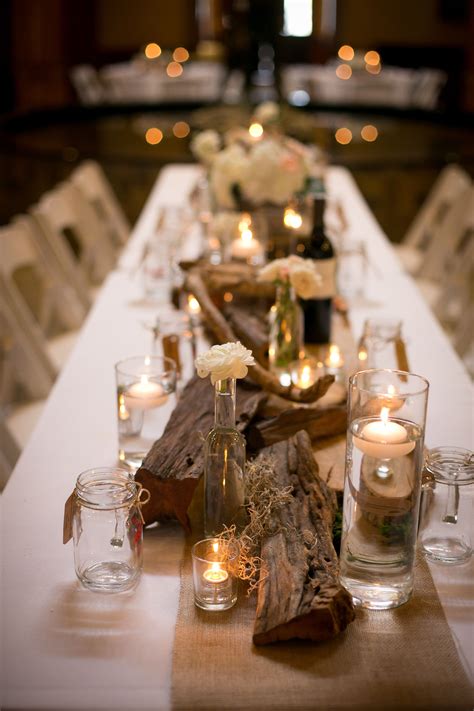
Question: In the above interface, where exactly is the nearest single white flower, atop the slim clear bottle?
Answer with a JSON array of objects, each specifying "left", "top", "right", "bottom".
[{"left": 194, "top": 341, "right": 255, "bottom": 385}]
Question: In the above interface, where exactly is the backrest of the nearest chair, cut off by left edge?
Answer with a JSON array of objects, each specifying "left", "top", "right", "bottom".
[{"left": 0, "top": 274, "right": 56, "bottom": 406}]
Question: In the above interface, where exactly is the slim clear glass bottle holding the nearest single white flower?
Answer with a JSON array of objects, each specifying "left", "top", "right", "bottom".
[{"left": 204, "top": 378, "right": 245, "bottom": 537}]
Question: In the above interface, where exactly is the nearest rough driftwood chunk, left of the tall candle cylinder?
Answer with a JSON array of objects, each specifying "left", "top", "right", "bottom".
[{"left": 253, "top": 432, "right": 354, "bottom": 645}]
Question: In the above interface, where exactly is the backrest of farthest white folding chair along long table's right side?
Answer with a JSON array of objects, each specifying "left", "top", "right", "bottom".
[{"left": 403, "top": 163, "right": 471, "bottom": 249}]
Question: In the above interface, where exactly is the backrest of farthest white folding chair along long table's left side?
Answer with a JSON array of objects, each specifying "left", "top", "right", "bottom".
[{"left": 70, "top": 160, "right": 130, "bottom": 247}]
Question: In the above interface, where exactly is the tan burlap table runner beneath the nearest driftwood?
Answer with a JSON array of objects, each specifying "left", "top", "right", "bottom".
[{"left": 172, "top": 548, "right": 474, "bottom": 711}]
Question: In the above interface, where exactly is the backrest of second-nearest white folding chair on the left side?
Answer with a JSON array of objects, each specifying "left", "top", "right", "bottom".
[{"left": 0, "top": 216, "right": 87, "bottom": 337}]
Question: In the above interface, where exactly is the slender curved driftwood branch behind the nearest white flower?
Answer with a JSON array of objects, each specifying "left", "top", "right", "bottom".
[{"left": 185, "top": 269, "right": 334, "bottom": 402}]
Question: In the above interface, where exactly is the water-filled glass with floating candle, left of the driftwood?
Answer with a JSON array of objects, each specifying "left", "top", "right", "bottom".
[{"left": 115, "top": 355, "right": 176, "bottom": 470}]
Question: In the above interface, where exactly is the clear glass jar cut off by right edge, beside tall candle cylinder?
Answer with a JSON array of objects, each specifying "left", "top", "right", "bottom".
[{"left": 419, "top": 447, "right": 474, "bottom": 565}]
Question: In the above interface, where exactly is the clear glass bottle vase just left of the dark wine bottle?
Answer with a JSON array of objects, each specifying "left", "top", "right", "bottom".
[{"left": 268, "top": 279, "right": 303, "bottom": 385}]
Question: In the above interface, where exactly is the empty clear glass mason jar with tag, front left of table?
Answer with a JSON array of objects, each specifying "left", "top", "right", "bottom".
[{"left": 72, "top": 468, "right": 149, "bottom": 592}]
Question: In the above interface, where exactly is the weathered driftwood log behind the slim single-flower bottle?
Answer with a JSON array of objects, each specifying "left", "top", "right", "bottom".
[{"left": 135, "top": 376, "right": 267, "bottom": 532}]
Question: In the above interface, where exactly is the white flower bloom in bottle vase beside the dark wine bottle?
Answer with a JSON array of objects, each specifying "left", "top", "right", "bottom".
[{"left": 258, "top": 255, "right": 323, "bottom": 299}]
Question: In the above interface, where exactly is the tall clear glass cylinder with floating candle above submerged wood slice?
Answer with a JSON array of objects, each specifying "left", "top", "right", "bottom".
[{"left": 340, "top": 370, "right": 429, "bottom": 610}]
